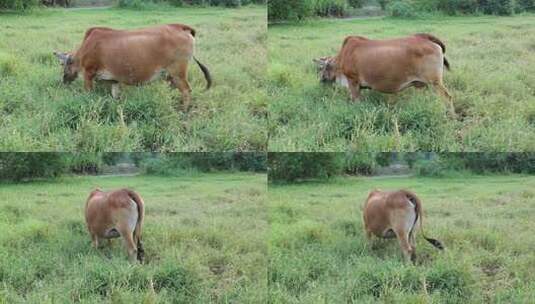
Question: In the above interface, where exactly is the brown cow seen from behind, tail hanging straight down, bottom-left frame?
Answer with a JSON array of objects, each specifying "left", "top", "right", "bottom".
[{"left": 85, "top": 189, "right": 145, "bottom": 262}]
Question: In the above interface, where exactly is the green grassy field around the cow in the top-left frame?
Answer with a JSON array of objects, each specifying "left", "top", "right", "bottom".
[{"left": 0, "top": 6, "right": 267, "bottom": 152}]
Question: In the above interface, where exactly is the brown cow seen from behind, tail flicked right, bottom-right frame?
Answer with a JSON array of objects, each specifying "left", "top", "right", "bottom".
[{"left": 363, "top": 190, "right": 444, "bottom": 262}]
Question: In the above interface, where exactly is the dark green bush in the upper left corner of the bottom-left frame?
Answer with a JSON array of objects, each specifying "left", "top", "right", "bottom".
[{"left": 0, "top": 153, "right": 68, "bottom": 182}]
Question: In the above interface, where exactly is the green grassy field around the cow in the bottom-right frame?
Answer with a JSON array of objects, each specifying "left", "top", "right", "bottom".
[{"left": 268, "top": 175, "right": 535, "bottom": 304}]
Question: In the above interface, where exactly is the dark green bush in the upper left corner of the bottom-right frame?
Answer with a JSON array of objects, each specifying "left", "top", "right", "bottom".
[{"left": 268, "top": 153, "right": 344, "bottom": 182}]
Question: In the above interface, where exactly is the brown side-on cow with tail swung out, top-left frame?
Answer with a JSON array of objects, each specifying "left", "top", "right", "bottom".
[{"left": 54, "top": 24, "right": 212, "bottom": 109}]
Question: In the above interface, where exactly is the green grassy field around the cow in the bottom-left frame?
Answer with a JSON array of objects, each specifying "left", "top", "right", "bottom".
[{"left": 0, "top": 173, "right": 268, "bottom": 303}]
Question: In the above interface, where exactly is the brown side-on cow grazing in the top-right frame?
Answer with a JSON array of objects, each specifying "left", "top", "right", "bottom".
[{"left": 314, "top": 34, "right": 454, "bottom": 113}]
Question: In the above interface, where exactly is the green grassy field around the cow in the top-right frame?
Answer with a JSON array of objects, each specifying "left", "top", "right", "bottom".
[{"left": 268, "top": 15, "right": 535, "bottom": 151}]
